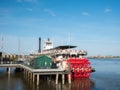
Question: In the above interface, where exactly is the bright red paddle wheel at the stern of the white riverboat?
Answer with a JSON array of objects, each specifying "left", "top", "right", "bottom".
[{"left": 67, "top": 58, "right": 92, "bottom": 78}]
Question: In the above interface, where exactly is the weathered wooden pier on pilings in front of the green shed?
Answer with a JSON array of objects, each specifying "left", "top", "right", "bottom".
[{"left": 0, "top": 64, "right": 71, "bottom": 85}]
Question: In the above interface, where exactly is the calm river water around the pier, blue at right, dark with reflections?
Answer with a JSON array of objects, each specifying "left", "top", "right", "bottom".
[{"left": 0, "top": 59, "right": 120, "bottom": 90}]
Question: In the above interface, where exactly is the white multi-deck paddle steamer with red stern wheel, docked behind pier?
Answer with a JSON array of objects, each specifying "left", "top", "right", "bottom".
[{"left": 36, "top": 39, "right": 94, "bottom": 78}]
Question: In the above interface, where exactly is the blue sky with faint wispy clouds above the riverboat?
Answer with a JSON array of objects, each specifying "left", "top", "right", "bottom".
[{"left": 0, "top": 0, "right": 120, "bottom": 56}]
